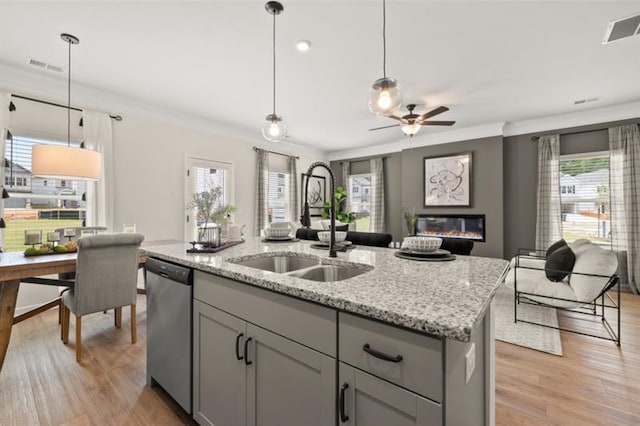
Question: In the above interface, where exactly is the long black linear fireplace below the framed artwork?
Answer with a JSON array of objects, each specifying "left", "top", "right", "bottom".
[{"left": 416, "top": 214, "right": 485, "bottom": 242}]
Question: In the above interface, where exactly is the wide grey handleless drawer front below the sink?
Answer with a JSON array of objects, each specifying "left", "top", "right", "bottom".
[{"left": 193, "top": 271, "right": 338, "bottom": 358}]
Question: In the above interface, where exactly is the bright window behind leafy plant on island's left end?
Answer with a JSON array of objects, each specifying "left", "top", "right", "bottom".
[{"left": 185, "top": 157, "right": 233, "bottom": 241}]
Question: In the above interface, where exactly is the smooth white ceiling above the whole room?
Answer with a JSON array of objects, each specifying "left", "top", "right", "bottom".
[{"left": 0, "top": 0, "right": 640, "bottom": 151}]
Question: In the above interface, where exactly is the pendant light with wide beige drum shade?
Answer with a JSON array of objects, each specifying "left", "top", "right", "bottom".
[{"left": 31, "top": 33, "right": 102, "bottom": 181}]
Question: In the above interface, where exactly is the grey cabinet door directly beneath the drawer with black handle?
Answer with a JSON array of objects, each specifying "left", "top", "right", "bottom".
[{"left": 338, "top": 363, "right": 442, "bottom": 426}]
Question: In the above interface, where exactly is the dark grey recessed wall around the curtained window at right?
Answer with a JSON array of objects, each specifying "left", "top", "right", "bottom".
[{"left": 502, "top": 119, "right": 639, "bottom": 258}]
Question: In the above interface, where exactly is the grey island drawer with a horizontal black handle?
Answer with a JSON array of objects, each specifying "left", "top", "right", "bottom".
[{"left": 338, "top": 312, "right": 444, "bottom": 402}]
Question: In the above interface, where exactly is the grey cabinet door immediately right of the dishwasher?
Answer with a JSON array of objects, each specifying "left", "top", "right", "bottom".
[{"left": 193, "top": 300, "right": 247, "bottom": 426}]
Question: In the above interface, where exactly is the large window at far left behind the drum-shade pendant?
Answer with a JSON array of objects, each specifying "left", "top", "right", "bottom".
[{"left": 2, "top": 135, "right": 86, "bottom": 251}]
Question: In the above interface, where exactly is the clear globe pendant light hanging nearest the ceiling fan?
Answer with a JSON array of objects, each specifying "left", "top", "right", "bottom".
[{"left": 369, "top": 0, "right": 402, "bottom": 116}]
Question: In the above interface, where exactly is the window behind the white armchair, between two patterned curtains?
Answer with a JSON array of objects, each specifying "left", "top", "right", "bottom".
[{"left": 560, "top": 152, "right": 611, "bottom": 246}]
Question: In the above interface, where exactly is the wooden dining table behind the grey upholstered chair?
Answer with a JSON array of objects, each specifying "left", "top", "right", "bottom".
[{"left": 0, "top": 252, "right": 146, "bottom": 372}]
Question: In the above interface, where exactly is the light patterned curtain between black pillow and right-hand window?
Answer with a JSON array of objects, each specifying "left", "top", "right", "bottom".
[{"left": 536, "top": 135, "right": 562, "bottom": 250}]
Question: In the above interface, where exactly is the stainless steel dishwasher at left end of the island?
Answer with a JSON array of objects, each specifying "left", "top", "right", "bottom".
[{"left": 145, "top": 258, "right": 193, "bottom": 413}]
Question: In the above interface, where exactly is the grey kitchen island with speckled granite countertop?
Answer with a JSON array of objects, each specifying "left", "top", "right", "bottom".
[{"left": 144, "top": 238, "right": 507, "bottom": 425}]
